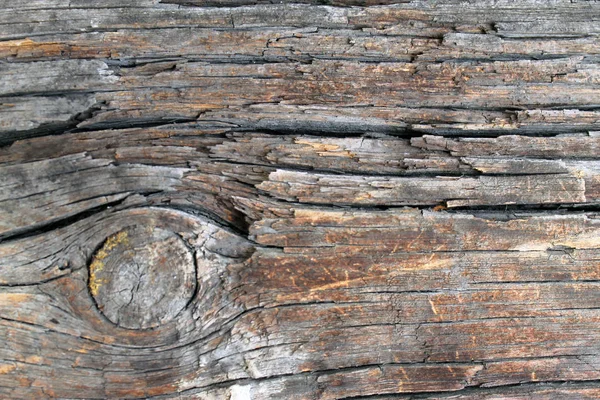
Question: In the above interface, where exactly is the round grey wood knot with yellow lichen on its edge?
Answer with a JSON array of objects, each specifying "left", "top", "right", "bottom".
[{"left": 88, "top": 226, "right": 197, "bottom": 329}]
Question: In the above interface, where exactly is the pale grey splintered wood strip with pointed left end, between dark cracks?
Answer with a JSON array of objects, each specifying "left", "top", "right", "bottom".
[{"left": 258, "top": 170, "right": 587, "bottom": 207}]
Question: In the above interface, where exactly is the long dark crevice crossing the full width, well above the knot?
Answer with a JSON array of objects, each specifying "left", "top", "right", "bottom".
[{"left": 0, "top": 101, "right": 600, "bottom": 148}]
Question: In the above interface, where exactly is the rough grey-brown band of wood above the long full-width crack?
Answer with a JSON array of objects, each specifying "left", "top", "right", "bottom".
[{"left": 0, "top": 2, "right": 598, "bottom": 141}]
